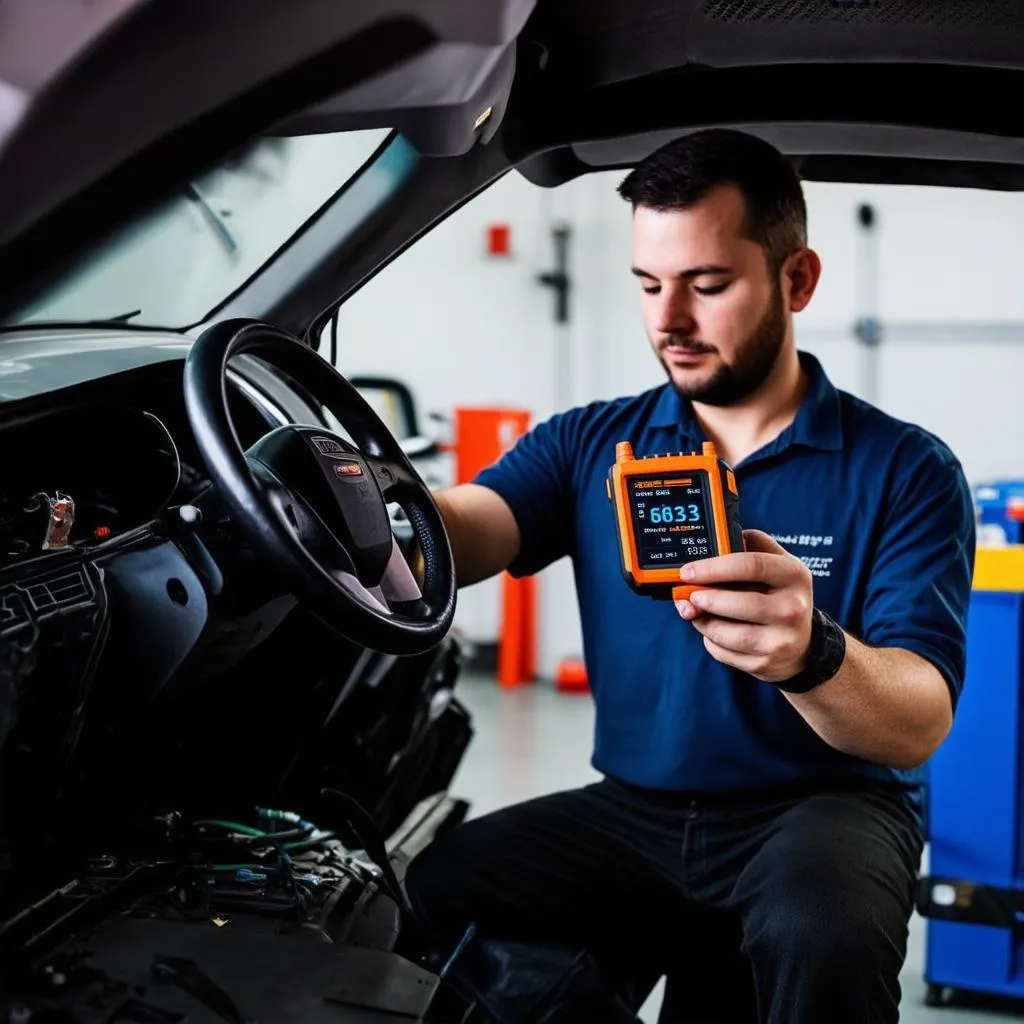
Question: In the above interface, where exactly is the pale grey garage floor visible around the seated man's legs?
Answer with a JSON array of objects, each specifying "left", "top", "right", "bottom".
[{"left": 454, "top": 676, "right": 1024, "bottom": 1024}]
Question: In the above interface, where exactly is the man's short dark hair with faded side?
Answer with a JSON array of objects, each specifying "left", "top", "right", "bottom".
[{"left": 618, "top": 128, "right": 807, "bottom": 273}]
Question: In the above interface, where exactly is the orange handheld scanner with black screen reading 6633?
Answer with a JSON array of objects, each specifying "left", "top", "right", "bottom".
[{"left": 607, "top": 441, "right": 743, "bottom": 600}]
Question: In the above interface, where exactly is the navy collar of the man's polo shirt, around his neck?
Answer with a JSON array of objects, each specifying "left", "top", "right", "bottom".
[{"left": 649, "top": 352, "right": 843, "bottom": 452}]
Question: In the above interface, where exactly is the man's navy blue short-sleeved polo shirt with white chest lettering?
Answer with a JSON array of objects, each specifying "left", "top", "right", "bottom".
[{"left": 476, "top": 353, "right": 975, "bottom": 806}]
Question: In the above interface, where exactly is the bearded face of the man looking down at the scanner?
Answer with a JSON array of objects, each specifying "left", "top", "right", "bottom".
[{"left": 633, "top": 185, "right": 787, "bottom": 406}]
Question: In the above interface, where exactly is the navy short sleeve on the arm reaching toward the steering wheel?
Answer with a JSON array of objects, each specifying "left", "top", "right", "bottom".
[{"left": 473, "top": 410, "right": 580, "bottom": 577}]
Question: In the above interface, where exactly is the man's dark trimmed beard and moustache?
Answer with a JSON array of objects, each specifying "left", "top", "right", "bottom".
[{"left": 659, "top": 286, "right": 785, "bottom": 406}]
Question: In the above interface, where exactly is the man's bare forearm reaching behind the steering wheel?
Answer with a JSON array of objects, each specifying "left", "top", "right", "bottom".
[{"left": 434, "top": 483, "right": 521, "bottom": 587}]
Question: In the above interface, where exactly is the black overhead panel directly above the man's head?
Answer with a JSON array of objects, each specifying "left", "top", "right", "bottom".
[{"left": 514, "top": 0, "right": 1024, "bottom": 188}]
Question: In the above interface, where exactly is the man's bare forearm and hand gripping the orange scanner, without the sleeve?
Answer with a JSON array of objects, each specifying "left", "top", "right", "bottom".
[{"left": 679, "top": 530, "right": 952, "bottom": 768}]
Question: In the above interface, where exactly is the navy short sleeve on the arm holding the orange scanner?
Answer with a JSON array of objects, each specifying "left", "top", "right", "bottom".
[{"left": 863, "top": 439, "right": 976, "bottom": 707}]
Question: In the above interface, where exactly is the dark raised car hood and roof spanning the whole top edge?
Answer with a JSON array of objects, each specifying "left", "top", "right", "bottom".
[{"left": 0, "top": 0, "right": 1024, "bottom": 323}]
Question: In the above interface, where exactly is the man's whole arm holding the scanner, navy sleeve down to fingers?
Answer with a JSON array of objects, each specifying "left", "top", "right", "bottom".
[{"left": 680, "top": 432, "right": 976, "bottom": 768}]
